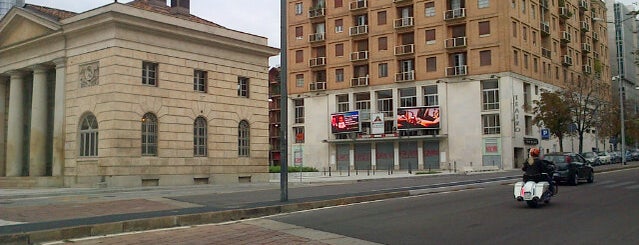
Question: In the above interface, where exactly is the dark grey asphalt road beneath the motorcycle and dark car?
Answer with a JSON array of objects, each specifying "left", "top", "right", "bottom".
[{"left": 270, "top": 168, "right": 639, "bottom": 244}]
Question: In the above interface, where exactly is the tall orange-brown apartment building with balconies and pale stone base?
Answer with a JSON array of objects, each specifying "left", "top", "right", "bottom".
[{"left": 287, "top": 0, "right": 610, "bottom": 170}]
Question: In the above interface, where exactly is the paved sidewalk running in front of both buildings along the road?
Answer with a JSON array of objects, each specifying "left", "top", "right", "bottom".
[{"left": 0, "top": 162, "right": 639, "bottom": 244}]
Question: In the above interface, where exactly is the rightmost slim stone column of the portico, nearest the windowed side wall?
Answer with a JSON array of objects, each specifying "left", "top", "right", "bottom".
[{"left": 51, "top": 58, "right": 67, "bottom": 176}]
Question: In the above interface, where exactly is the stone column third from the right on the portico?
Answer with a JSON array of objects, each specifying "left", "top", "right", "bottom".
[{"left": 7, "top": 71, "right": 24, "bottom": 177}]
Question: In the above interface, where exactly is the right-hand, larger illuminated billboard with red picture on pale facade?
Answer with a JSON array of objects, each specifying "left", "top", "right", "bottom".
[{"left": 397, "top": 106, "right": 440, "bottom": 130}]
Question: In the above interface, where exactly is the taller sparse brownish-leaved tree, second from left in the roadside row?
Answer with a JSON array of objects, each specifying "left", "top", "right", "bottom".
[{"left": 560, "top": 79, "right": 608, "bottom": 153}]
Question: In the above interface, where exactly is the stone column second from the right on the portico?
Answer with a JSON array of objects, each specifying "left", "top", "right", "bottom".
[{"left": 29, "top": 65, "right": 47, "bottom": 176}]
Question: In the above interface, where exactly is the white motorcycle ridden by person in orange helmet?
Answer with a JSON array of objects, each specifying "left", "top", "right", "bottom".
[{"left": 514, "top": 173, "right": 558, "bottom": 208}]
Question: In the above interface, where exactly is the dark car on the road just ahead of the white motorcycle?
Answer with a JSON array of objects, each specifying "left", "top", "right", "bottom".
[{"left": 544, "top": 152, "right": 595, "bottom": 185}]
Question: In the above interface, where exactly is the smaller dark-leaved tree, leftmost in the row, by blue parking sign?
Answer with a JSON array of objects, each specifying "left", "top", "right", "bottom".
[{"left": 533, "top": 91, "right": 572, "bottom": 152}]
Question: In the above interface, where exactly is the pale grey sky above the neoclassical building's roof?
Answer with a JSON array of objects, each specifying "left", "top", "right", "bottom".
[{"left": 25, "top": 0, "right": 280, "bottom": 66}]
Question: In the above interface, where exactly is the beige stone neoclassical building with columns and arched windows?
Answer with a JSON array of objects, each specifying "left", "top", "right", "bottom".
[{"left": 0, "top": 0, "right": 279, "bottom": 187}]
